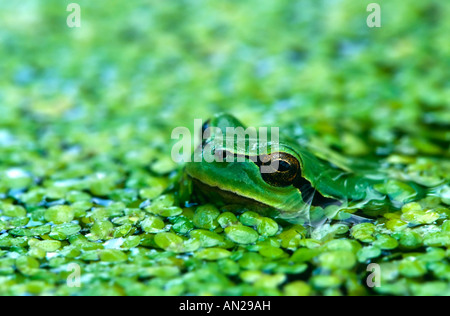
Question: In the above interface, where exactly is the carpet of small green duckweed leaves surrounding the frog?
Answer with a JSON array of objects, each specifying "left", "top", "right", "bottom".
[{"left": 0, "top": 0, "right": 450, "bottom": 296}]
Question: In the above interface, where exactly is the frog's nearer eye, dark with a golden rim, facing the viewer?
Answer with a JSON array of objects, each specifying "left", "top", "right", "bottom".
[{"left": 259, "top": 152, "right": 300, "bottom": 187}]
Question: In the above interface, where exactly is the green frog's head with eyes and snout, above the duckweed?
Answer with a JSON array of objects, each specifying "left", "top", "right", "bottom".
[{"left": 185, "top": 114, "right": 326, "bottom": 220}]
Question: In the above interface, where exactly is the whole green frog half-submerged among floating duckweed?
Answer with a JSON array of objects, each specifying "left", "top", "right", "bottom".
[{"left": 179, "top": 113, "right": 426, "bottom": 226}]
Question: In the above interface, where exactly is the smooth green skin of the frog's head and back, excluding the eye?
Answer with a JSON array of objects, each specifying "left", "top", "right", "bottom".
[{"left": 185, "top": 114, "right": 426, "bottom": 219}]
